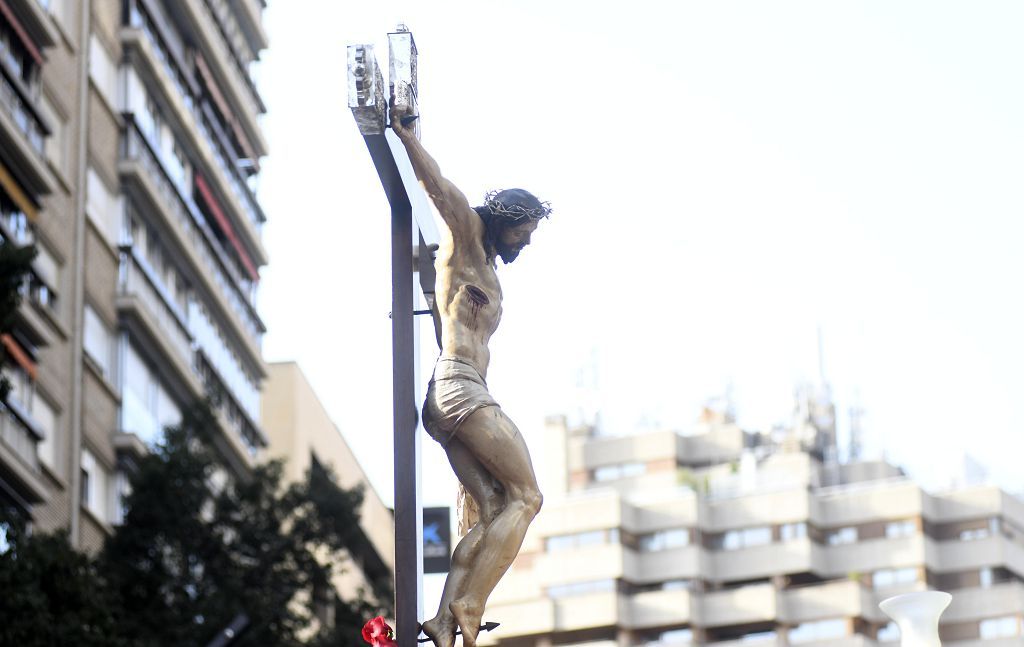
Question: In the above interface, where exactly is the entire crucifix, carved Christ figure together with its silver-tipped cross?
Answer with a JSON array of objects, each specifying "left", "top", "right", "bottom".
[{"left": 349, "top": 29, "right": 551, "bottom": 647}]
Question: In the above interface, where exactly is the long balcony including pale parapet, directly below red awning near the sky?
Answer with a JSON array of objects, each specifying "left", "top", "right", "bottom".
[{"left": 119, "top": 115, "right": 265, "bottom": 368}]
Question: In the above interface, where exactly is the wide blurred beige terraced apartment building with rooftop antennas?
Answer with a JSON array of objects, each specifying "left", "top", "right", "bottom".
[{"left": 482, "top": 399, "right": 1024, "bottom": 647}]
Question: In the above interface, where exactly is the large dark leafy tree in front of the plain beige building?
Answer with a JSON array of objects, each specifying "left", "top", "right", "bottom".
[{"left": 99, "top": 405, "right": 390, "bottom": 647}]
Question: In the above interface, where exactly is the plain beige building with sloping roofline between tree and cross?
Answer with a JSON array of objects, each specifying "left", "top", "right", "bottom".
[{"left": 262, "top": 361, "right": 394, "bottom": 623}]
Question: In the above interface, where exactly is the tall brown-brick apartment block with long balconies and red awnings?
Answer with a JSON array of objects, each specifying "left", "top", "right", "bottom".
[{"left": 0, "top": 0, "right": 267, "bottom": 549}]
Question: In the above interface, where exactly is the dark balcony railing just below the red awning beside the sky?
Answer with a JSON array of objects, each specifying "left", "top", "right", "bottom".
[{"left": 122, "top": 115, "right": 263, "bottom": 348}]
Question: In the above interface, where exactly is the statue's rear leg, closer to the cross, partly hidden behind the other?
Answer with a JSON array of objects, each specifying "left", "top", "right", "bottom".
[{"left": 423, "top": 437, "right": 505, "bottom": 647}]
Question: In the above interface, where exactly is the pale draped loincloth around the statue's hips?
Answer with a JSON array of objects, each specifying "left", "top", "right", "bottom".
[{"left": 423, "top": 357, "right": 498, "bottom": 446}]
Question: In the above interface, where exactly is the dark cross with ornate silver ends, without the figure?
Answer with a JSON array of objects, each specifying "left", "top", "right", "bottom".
[{"left": 348, "top": 25, "right": 440, "bottom": 647}]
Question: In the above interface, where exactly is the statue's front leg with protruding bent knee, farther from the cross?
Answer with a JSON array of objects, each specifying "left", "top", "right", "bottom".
[{"left": 449, "top": 406, "right": 542, "bottom": 647}]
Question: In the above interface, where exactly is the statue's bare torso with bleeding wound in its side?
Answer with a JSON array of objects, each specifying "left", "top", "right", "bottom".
[{"left": 434, "top": 226, "right": 502, "bottom": 378}]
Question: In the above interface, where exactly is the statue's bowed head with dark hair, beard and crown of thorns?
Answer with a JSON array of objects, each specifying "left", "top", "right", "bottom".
[{"left": 475, "top": 188, "right": 551, "bottom": 263}]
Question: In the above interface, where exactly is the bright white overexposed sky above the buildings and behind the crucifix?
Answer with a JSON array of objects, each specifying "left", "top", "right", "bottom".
[{"left": 259, "top": 0, "right": 1024, "bottom": 515}]
